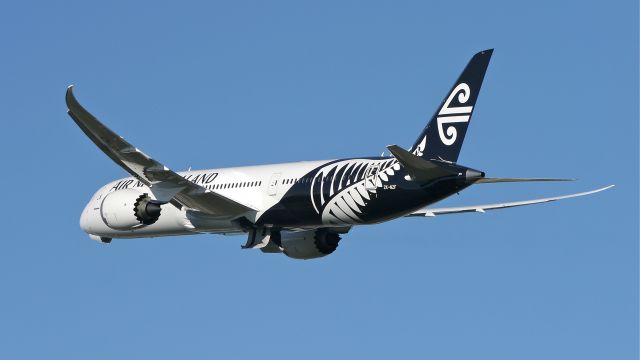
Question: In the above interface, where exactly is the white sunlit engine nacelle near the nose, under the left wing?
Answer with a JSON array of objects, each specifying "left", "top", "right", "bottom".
[{"left": 100, "top": 189, "right": 161, "bottom": 230}]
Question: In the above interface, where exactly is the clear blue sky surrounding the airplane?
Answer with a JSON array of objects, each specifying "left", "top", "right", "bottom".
[{"left": 0, "top": 1, "right": 638, "bottom": 360}]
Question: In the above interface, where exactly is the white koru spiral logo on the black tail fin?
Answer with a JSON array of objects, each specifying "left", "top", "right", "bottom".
[{"left": 438, "top": 83, "right": 473, "bottom": 146}]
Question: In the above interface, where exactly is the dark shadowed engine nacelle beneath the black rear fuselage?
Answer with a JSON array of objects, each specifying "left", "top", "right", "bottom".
[{"left": 280, "top": 229, "right": 340, "bottom": 260}]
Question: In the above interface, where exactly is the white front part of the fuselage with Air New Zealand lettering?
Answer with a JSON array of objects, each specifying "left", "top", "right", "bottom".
[{"left": 80, "top": 160, "right": 331, "bottom": 238}]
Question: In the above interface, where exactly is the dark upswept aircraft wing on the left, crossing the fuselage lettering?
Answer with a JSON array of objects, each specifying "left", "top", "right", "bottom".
[{"left": 66, "top": 86, "right": 255, "bottom": 217}]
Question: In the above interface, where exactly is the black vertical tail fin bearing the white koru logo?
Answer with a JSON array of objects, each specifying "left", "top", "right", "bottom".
[{"left": 411, "top": 49, "right": 493, "bottom": 162}]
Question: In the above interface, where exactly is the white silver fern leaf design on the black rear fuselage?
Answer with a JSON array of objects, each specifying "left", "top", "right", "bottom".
[{"left": 309, "top": 159, "right": 400, "bottom": 225}]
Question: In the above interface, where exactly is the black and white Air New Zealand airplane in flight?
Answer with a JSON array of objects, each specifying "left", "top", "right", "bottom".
[{"left": 66, "top": 49, "right": 613, "bottom": 259}]
